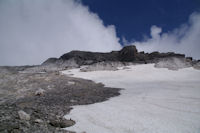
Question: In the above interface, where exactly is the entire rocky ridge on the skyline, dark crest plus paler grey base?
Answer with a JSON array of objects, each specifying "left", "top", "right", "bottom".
[{"left": 39, "top": 45, "right": 199, "bottom": 71}]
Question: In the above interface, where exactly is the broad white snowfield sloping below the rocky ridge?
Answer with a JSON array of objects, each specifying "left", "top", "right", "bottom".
[{"left": 63, "top": 64, "right": 200, "bottom": 133}]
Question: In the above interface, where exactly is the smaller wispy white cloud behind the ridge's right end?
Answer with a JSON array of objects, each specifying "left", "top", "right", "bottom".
[{"left": 130, "top": 13, "right": 200, "bottom": 59}]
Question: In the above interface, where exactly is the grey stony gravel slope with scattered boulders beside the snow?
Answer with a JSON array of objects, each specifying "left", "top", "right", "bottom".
[{"left": 0, "top": 67, "right": 120, "bottom": 133}]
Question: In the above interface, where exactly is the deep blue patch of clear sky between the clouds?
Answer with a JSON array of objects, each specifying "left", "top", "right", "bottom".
[{"left": 82, "top": 0, "right": 200, "bottom": 41}]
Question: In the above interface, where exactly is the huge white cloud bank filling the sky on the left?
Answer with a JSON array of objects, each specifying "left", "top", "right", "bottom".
[{"left": 0, "top": 0, "right": 121, "bottom": 65}]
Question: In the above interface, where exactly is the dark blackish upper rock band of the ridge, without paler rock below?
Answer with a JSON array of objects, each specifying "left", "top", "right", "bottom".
[{"left": 42, "top": 45, "right": 189, "bottom": 68}]
